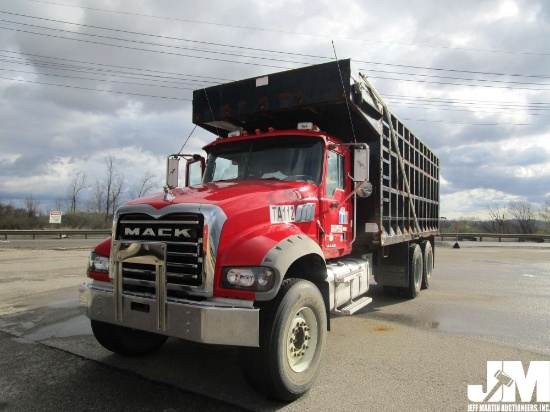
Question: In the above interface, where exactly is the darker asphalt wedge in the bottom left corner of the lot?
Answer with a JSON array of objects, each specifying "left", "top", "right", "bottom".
[{"left": 0, "top": 332, "right": 246, "bottom": 412}]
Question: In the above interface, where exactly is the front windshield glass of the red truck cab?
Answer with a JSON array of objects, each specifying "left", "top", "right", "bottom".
[{"left": 203, "top": 136, "right": 324, "bottom": 185}]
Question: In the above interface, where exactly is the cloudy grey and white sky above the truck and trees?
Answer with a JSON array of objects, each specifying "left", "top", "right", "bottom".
[{"left": 0, "top": 0, "right": 550, "bottom": 218}]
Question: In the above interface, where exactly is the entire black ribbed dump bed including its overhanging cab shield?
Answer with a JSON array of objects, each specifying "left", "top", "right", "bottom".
[{"left": 193, "top": 60, "right": 439, "bottom": 247}]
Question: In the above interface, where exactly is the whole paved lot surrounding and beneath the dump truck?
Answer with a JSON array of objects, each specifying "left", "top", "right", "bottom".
[{"left": 0, "top": 239, "right": 550, "bottom": 411}]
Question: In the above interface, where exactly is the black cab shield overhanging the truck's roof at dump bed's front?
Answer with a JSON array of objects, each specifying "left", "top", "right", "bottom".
[{"left": 193, "top": 60, "right": 382, "bottom": 142}]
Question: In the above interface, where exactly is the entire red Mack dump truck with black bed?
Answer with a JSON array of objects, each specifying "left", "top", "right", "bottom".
[{"left": 80, "top": 60, "right": 439, "bottom": 401}]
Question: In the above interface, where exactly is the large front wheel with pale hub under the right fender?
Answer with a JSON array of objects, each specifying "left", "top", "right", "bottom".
[{"left": 239, "top": 279, "right": 327, "bottom": 401}]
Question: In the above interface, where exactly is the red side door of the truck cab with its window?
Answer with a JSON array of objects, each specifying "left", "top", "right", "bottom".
[{"left": 321, "top": 148, "right": 353, "bottom": 258}]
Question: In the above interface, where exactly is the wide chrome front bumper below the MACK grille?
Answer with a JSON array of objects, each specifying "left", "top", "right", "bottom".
[{"left": 80, "top": 283, "right": 260, "bottom": 347}]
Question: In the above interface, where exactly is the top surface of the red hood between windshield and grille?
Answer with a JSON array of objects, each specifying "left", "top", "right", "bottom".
[{"left": 127, "top": 180, "right": 318, "bottom": 216}]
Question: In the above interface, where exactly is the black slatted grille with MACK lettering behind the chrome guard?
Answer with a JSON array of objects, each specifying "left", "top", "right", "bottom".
[{"left": 116, "top": 214, "right": 204, "bottom": 297}]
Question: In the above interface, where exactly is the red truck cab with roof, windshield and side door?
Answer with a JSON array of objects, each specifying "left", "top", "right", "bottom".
[{"left": 203, "top": 126, "right": 360, "bottom": 259}]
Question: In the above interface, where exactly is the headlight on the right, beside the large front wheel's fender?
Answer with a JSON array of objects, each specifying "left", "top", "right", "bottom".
[{"left": 222, "top": 266, "right": 275, "bottom": 292}]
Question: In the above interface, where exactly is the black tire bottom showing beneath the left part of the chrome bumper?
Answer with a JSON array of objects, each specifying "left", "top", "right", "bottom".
[{"left": 92, "top": 320, "right": 168, "bottom": 356}]
